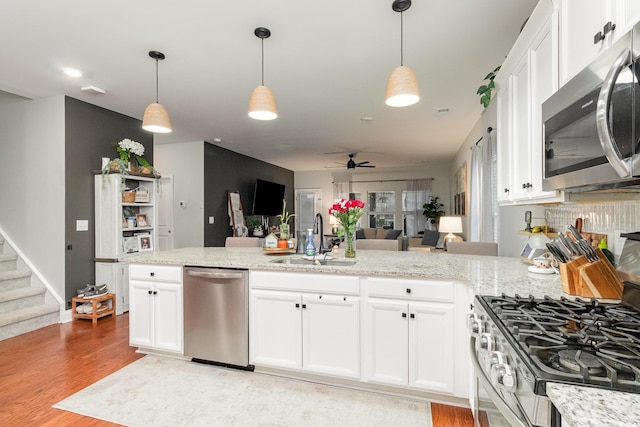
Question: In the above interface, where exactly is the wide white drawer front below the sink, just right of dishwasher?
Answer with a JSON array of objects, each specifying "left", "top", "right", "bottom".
[{"left": 249, "top": 271, "right": 360, "bottom": 295}]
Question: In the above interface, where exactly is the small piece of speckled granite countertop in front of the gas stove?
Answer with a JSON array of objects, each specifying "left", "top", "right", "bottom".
[{"left": 547, "top": 383, "right": 640, "bottom": 427}]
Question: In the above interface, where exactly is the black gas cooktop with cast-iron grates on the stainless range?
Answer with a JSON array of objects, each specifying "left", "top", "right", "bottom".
[{"left": 479, "top": 295, "right": 640, "bottom": 393}]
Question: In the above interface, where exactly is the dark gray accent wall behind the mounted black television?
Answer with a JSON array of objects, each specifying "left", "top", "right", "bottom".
[{"left": 203, "top": 144, "right": 295, "bottom": 246}]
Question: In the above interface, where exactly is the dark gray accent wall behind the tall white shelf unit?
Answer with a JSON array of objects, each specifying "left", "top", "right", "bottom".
[{"left": 60, "top": 97, "right": 153, "bottom": 308}]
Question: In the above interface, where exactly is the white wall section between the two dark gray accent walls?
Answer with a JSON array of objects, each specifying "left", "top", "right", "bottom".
[{"left": 153, "top": 141, "right": 205, "bottom": 249}]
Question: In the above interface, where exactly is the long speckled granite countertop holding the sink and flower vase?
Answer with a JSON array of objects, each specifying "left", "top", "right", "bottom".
[{"left": 122, "top": 247, "right": 562, "bottom": 298}]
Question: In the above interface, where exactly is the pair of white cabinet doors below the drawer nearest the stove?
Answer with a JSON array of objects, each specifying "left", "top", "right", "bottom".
[{"left": 365, "top": 299, "right": 455, "bottom": 394}]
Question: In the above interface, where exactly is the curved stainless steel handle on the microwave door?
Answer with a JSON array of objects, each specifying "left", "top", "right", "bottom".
[{"left": 596, "top": 49, "right": 631, "bottom": 177}]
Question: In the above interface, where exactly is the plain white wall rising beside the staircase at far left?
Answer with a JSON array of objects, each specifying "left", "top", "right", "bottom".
[{"left": 0, "top": 96, "right": 65, "bottom": 297}]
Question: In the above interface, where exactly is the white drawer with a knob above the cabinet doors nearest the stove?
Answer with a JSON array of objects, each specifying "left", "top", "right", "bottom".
[{"left": 364, "top": 278, "right": 455, "bottom": 302}]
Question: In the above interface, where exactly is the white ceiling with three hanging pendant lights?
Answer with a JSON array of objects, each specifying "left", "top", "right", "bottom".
[{"left": 0, "top": 0, "right": 537, "bottom": 171}]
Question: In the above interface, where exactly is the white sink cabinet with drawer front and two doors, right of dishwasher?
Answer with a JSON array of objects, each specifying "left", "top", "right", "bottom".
[{"left": 249, "top": 272, "right": 360, "bottom": 378}]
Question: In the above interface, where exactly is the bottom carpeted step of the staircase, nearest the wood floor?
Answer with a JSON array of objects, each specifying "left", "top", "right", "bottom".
[{"left": 0, "top": 304, "right": 60, "bottom": 341}]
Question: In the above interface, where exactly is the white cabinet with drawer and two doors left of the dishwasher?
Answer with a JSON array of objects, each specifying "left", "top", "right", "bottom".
[{"left": 129, "top": 265, "right": 184, "bottom": 354}]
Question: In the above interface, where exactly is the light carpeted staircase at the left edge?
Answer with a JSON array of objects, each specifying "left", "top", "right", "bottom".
[{"left": 0, "top": 236, "right": 60, "bottom": 341}]
